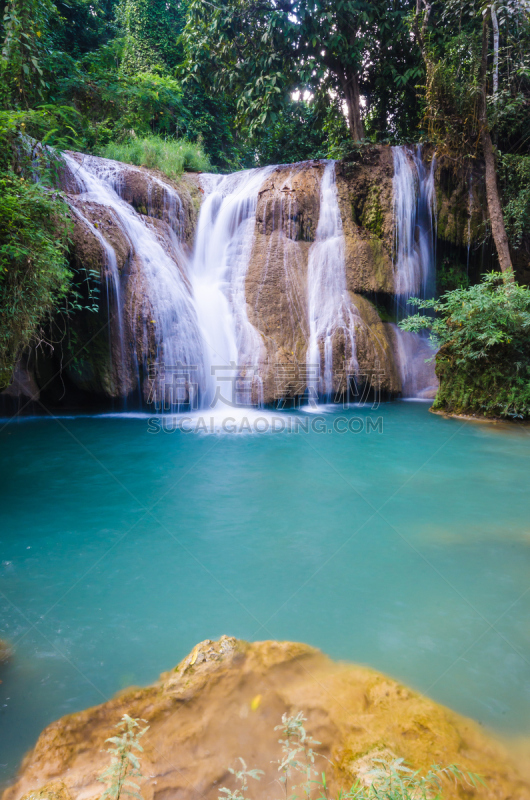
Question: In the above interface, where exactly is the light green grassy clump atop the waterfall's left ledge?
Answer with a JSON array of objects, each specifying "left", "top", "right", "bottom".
[{"left": 100, "top": 136, "right": 211, "bottom": 178}]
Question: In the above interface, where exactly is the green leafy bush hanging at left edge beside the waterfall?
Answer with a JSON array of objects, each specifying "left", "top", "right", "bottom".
[{"left": 0, "top": 172, "right": 72, "bottom": 386}]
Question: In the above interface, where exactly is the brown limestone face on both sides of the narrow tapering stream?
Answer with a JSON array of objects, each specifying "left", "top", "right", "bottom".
[{"left": 246, "top": 153, "right": 401, "bottom": 402}]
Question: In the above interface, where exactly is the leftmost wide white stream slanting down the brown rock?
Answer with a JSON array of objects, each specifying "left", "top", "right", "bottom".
[{"left": 64, "top": 154, "right": 205, "bottom": 405}]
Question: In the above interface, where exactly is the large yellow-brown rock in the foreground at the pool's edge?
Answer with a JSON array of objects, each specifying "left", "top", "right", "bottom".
[{"left": 3, "top": 636, "right": 530, "bottom": 800}]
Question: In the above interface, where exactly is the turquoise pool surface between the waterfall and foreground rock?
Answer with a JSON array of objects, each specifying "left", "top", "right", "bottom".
[{"left": 0, "top": 403, "right": 530, "bottom": 779}]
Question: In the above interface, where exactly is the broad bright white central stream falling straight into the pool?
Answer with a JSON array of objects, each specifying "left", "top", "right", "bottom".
[{"left": 190, "top": 166, "right": 275, "bottom": 405}]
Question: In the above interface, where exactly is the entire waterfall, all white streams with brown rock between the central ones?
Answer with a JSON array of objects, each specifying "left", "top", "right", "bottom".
[{"left": 56, "top": 147, "right": 442, "bottom": 411}]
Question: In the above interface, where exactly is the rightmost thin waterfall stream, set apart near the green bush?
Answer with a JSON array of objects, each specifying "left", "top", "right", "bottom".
[{"left": 392, "top": 145, "right": 436, "bottom": 397}]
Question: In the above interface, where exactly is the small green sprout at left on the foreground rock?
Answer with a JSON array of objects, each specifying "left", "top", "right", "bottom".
[{"left": 98, "top": 714, "right": 149, "bottom": 800}]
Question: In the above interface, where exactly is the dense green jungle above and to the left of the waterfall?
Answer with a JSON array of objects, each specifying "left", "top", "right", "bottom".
[{"left": 0, "top": 0, "right": 530, "bottom": 412}]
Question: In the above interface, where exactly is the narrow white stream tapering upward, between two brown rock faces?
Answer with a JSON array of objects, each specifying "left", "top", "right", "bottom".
[{"left": 306, "top": 161, "right": 361, "bottom": 403}]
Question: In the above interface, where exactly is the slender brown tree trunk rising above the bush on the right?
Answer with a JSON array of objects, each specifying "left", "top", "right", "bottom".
[{"left": 480, "top": 8, "right": 512, "bottom": 273}]
